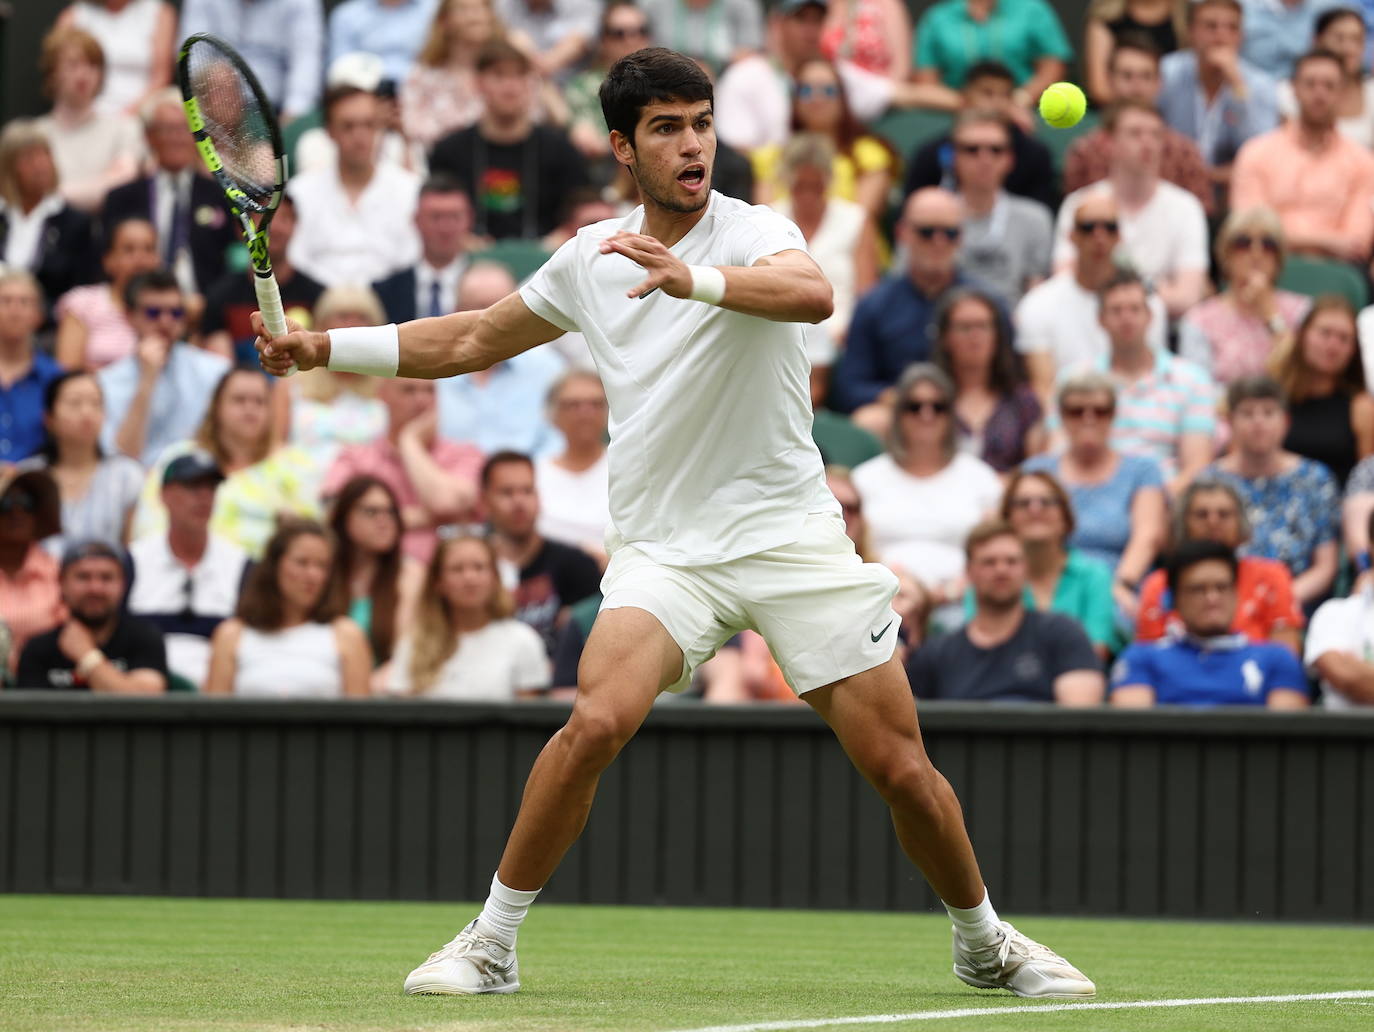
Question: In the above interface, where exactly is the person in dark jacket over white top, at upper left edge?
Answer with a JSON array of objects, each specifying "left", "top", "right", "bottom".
[{"left": 0, "top": 118, "right": 99, "bottom": 312}]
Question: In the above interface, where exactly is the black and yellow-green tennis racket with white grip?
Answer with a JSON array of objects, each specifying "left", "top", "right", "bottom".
[{"left": 177, "top": 33, "right": 295, "bottom": 375}]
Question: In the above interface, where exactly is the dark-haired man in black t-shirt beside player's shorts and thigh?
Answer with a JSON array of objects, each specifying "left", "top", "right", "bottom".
[{"left": 482, "top": 452, "right": 600, "bottom": 655}]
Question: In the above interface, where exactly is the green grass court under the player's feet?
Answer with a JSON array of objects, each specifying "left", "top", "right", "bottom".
[{"left": 0, "top": 896, "right": 1374, "bottom": 1032}]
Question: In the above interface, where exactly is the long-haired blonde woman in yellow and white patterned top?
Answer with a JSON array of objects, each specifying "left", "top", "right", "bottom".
[{"left": 133, "top": 370, "right": 323, "bottom": 558}]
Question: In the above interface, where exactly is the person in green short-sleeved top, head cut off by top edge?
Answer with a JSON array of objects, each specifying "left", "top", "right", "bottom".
[{"left": 912, "top": 0, "right": 1073, "bottom": 110}]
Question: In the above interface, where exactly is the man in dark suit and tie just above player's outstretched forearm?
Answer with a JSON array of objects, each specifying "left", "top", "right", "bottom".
[{"left": 372, "top": 173, "right": 473, "bottom": 323}]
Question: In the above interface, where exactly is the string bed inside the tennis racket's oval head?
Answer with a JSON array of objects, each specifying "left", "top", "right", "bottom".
[{"left": 187, "top": 40, "right": 278, "bottom": 207}]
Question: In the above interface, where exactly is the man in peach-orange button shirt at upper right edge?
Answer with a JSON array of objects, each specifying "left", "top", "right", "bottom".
[{"left": 1231, "top": 51, "right": 1374, "bottom": 262}]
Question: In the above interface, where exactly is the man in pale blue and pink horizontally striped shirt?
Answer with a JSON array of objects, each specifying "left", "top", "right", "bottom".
[{"left": 1051, "top": 271, "right": 1216, "bottom": 495}]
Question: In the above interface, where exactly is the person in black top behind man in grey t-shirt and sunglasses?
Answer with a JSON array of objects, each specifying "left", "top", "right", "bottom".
[{"left": 903, "top": 60, "right": 1059, "bottom": 212}]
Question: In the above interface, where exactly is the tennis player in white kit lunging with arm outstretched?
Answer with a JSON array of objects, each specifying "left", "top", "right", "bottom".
[{"left": 254, "top": 48, "right": 1095, "bottom": 998}]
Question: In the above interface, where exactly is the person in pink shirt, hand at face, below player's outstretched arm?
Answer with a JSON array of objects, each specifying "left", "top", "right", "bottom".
[{"left": 323, "top": 379, "right": 482, "bottom": 562}]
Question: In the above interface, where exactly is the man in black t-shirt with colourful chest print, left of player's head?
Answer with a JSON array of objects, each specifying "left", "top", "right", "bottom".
[{"left": 430, "top": 40, "right": 587, "bottom": 240}]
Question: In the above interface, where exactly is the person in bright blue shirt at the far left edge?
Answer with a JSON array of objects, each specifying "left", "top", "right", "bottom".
[{"left": 0, "top": 269, "right": 62, "bottom": 466}]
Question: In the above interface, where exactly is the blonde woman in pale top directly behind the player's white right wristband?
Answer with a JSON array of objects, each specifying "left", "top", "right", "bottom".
[{"left": 273, "top": 286, "right": 386, "bottom": 469}]
